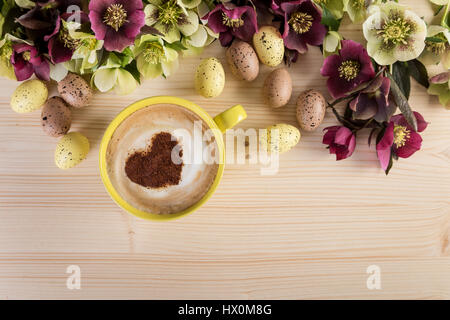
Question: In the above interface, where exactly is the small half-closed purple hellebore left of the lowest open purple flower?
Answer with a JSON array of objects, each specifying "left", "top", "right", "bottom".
[{"left": 322, "top": 126, "right": 356, "bottom": 160}]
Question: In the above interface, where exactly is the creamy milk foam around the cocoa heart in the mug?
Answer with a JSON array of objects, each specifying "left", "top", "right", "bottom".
[{"left": 107, "top": 104, "right": 218, "bottom": 214}]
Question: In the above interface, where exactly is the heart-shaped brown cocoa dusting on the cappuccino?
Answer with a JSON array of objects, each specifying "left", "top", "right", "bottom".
[{"left": 125, "top": 132, "right": 183, "bottom": 188}]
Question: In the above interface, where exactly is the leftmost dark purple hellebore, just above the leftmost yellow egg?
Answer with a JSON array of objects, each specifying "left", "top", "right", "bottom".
[{"left": 11, "top": 43, "right": 50, "bottom": 81}]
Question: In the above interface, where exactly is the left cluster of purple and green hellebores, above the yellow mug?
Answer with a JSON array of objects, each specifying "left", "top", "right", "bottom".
[{"left": 0, "top": 0, "right": 218, "bottom": 94}]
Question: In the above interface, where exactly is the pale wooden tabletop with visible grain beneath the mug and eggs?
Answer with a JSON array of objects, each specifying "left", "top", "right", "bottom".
[{"left": 0, "top": 1, "right": 450, "bottom": 299}]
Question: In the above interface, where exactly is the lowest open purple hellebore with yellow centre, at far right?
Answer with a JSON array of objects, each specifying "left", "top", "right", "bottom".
[{"left": 377, "top": 111, "right": 428, "bottom": 171}]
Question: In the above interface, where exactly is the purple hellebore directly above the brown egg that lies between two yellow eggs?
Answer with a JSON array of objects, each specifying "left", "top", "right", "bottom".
[{"left": 202, "top": 3, "right": 258, "bottom": 47}]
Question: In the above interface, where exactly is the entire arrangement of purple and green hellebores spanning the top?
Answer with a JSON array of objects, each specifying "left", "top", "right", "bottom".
[{"left": 0, "top": 0, "right": 450, "bottom": 172}]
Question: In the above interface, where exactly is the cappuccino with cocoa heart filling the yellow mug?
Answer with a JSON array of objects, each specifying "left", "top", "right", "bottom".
[{"left": 106, "top": 104, "right": 219, "bottom": 214}]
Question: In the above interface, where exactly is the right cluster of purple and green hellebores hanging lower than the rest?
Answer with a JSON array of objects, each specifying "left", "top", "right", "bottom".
[{"left": 206, "top": 0, "right": 450, "bottom": 173}]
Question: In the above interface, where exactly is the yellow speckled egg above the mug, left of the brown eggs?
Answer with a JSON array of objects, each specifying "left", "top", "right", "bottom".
[{"left": 195, "top": 58, "right": 225, "bottom": 98}]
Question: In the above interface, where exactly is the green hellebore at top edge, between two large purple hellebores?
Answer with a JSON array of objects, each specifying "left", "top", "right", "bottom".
[{"left": 144, "top": 0, "right": 199, "bottom": 43}]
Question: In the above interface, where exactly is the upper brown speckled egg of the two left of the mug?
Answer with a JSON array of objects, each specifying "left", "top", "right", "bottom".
[{"left": 58, "top": 73, "right": 92, "bottom": 108}]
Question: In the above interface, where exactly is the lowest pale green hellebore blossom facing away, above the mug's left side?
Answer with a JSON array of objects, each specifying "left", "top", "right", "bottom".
[{"left": 91, "top": 53, "right": 138, "bottom": 95}]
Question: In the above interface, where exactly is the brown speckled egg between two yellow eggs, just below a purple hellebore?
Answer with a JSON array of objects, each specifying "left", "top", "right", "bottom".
[{"left": 226, "top": 39, "right": 259, "bottom": 81}]
